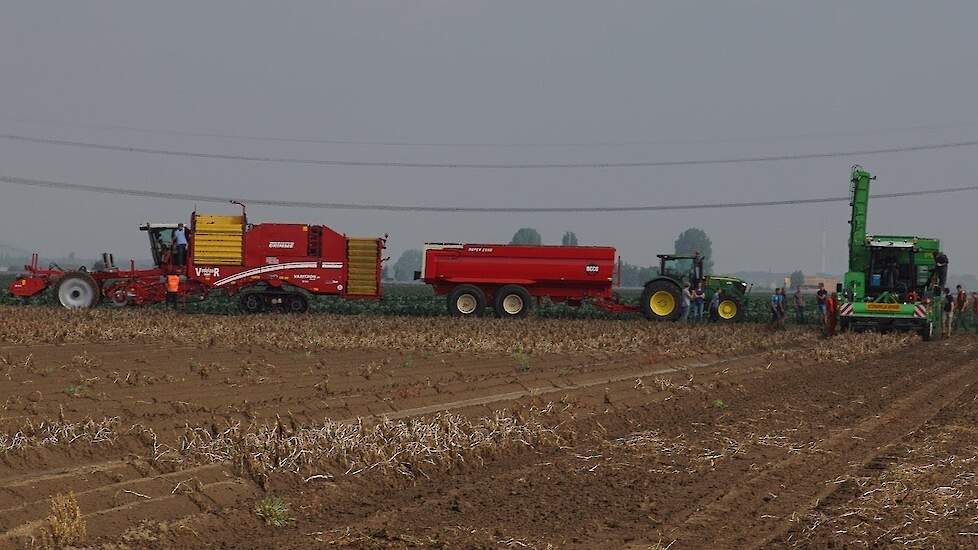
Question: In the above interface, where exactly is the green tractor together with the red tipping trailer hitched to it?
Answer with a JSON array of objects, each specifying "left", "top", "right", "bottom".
[{"left": 415, "top": 243, "right": 747, "bottom": 322}]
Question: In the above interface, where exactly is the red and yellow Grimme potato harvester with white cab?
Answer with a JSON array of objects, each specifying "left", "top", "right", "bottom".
[{"left": 9, "top": 203, "right": 386, "bottom": 313}]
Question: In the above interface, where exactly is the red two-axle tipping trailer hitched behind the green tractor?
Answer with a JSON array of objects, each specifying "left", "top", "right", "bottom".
[{"left": 416, "top": 243, "right": 637, "bottom": 317}]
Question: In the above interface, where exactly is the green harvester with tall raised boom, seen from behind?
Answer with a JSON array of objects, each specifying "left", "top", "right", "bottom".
[{"left": 837, "top": 166, "right": 941, "bottom": 340}]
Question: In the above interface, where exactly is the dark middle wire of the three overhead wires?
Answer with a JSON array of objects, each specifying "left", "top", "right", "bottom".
[{"left": 0, "top": 134, "right": 978, "bottom": 170}]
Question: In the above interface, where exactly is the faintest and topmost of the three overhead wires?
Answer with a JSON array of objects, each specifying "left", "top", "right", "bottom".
[{"left": 3, "top": 118, "right": 978, "bottom": 149}]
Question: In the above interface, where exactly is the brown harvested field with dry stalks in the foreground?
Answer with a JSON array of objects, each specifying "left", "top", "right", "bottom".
[{"left": 0, "top": 307, "right": 978, "bottom": 549}]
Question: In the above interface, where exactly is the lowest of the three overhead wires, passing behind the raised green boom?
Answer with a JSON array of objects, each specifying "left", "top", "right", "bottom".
[{"left": 0, "top": 176, "right": 978, "bottom": 213}]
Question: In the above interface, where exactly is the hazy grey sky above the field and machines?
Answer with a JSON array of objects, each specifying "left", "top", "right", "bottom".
[{"left": 0, "top": 0, "right": 978, "bottom": 273}]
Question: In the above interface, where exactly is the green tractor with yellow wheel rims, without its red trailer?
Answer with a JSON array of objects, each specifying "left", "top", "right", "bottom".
[{"left": 639, "top": 254, "right": 748, "bottom": 323}]
